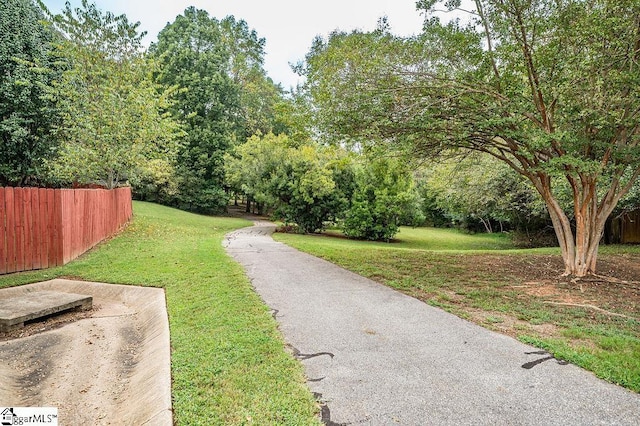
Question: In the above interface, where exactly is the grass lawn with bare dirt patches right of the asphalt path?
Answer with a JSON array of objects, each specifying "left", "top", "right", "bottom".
[{"left": 274, "top": 228, "right": 640, "bottom": 392}]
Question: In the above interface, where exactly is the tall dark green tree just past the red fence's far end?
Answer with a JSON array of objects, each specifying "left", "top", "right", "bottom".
[{"left": 150, "top": 7, "right": 282, "bottom": 213}]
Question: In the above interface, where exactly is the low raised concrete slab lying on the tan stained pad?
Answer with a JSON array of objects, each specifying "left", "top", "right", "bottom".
[{"left": 0, "top": 291, "right": 93, "bottom": 331}]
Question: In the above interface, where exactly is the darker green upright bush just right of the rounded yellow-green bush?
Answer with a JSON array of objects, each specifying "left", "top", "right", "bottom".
[{"left": 343, "top": 159, "right": 424, "bottom": 241}]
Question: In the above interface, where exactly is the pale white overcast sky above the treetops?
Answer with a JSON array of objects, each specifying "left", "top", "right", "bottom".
[{"left": 44, "top": 0, "right": 422, "bottom": 89}]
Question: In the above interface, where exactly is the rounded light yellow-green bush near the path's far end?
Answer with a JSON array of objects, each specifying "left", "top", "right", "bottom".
[{"left": 225, "top": 134, "right": 351, "bottom": 232}]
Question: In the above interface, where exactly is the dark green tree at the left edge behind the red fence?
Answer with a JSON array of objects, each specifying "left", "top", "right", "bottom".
[{"left": 0, "top": 0, "right": 61, "bottom": 186}]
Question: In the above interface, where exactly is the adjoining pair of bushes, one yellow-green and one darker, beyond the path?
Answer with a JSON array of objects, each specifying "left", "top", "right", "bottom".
[{"left": 225, "top": 134, "right": 424, "bottom": 241}]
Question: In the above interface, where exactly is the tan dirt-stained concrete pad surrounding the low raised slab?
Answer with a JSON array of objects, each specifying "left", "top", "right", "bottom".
[{"left": 0, "top": 279, "right": 173, "bottom": 425}]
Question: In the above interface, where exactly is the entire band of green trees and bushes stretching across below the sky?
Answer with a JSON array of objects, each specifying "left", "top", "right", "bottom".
[{"left": 5, "top": 0, "right": 640, "bottom": 275}]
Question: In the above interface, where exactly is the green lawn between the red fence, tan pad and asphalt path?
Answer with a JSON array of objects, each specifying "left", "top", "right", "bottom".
[{"left": 0, "top": 202, "right": 320, "bottom": 425}]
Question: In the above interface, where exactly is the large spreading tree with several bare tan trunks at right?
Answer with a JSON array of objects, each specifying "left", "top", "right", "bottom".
[{"left": 306, "top": 0, "right": 640, "bottom": 276}]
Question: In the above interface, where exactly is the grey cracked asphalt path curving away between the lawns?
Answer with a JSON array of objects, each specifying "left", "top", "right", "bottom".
[{"left": 224, "top": 222, "right": 640, "bottom": 425}]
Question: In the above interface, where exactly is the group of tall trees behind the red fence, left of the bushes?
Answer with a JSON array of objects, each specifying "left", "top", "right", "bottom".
[{"left": 0, "top": 0, "right": 291, "bottom": 212}]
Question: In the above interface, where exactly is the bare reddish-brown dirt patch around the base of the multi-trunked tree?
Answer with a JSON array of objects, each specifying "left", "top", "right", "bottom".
[{"left": 400, "top": 254, "right": 640, "bottom": 345}]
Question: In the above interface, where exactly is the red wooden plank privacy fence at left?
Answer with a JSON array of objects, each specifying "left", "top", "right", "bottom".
[{"left": 0, "top": 188, "right": 133, "bottom": 274}]
